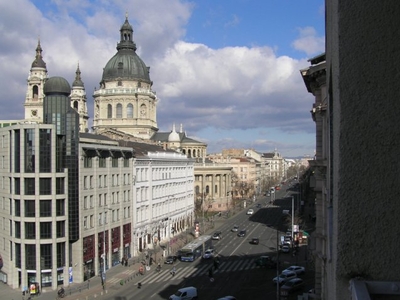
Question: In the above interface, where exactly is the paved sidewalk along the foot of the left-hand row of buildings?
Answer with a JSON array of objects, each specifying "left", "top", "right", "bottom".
[{"left": 0, "top": 217, "right": 227, "bottom": 300}]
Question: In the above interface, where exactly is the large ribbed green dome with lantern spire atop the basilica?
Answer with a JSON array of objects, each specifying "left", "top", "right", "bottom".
[{"left": 102, "top": 18, "right": 151, "bottom": 82}]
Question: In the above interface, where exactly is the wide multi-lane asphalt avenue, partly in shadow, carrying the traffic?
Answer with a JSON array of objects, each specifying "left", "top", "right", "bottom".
[{"left": 99, "top": 187, "right": 314, "bottom": 300}]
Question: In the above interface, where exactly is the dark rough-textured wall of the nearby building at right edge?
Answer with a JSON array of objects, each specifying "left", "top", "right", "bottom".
[{"left": 324, "top": 0, "right": 400, "bottom": 299}]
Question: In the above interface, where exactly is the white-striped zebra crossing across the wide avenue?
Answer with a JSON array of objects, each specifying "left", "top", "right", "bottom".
[{"left": 126, "top": 258, "right": 258, "bottom": 284}]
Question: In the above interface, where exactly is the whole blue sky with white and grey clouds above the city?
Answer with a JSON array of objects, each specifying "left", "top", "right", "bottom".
[{"left": 0, "top": 0, "right": 325, "bottom": 158}]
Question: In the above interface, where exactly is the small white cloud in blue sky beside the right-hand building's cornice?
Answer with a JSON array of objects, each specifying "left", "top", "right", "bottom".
[{"left": 292, "top": 27, "right": 325, "bottom": 56}]
